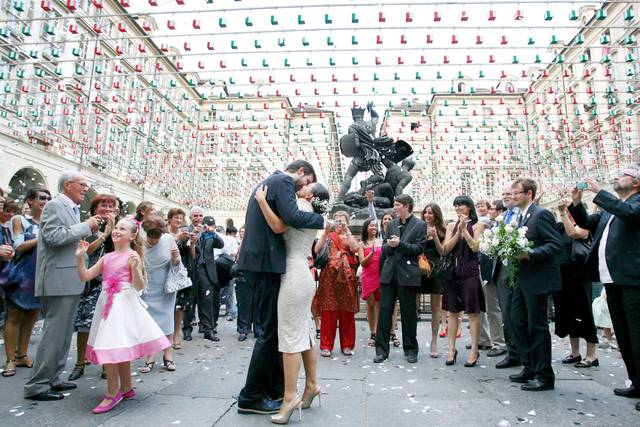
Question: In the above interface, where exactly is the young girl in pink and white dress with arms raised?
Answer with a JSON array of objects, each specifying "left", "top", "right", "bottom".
[{"left": 76, "top": 218, "right": 171, "bottom": 414}]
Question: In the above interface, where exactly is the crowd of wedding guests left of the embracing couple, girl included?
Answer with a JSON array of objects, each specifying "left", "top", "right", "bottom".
[{"left": 0, "top": 172, "right": 245, "bottom": 413}]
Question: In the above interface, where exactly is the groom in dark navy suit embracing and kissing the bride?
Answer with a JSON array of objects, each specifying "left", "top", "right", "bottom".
[{"left": 238, "top": 160, "right": 324, "bottom": 414}]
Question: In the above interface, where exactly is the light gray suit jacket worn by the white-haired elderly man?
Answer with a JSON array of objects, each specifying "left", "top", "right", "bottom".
[{"left": 35, "top": 196, "right": 92, "bottom": 297}]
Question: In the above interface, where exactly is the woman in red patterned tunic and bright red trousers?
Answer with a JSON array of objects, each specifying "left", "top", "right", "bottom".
[{"left": 312, "top": 211, "right": 358, "bottom": 357}]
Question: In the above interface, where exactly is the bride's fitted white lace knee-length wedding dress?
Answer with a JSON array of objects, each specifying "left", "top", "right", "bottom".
[{"left": 278, "top": 199, "right": 318, "bottom": 353}]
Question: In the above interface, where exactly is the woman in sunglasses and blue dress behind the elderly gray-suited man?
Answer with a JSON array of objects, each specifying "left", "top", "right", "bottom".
[{"left": 2, "top": 187, "right": 51, "bottom": 377}]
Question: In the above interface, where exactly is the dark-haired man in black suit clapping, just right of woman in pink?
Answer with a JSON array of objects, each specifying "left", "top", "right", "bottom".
[{"left": 373, "top": 194, "right": 427, "bottom": 363}]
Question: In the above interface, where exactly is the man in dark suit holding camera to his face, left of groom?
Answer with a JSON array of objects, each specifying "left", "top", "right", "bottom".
[{"left": 191, "top": 216, "right": 224, "bottom": 341}]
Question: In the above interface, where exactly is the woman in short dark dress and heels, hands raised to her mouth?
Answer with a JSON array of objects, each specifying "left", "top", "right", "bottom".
[{"left": 442, "top": 196, "right": 485, "bottom": 367}]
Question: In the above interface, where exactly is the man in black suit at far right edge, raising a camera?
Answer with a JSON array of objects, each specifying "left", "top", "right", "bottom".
[{"left": 569, "top": 164, "right": 640, "bottom": 411}]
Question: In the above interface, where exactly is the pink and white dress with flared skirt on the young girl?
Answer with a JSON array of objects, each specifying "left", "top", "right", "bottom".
[{"left": 86, "top": 250, "right": 171, "bottom": 364}]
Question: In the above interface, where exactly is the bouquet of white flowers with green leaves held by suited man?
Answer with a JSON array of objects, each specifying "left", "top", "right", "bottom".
[{"left": 478, "top": 216, "right": 533, "bottom": 287}]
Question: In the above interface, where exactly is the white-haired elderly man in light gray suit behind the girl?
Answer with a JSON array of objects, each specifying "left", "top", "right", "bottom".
[{"left": 24, "top": 172, "right": 102, "bottom": 400}]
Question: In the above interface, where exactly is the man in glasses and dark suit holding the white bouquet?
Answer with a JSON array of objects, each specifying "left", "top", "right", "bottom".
[{"left": 509, "top": 178, "right": 562, "bottom": 391}]
